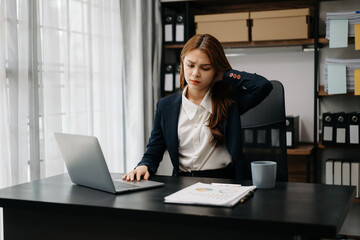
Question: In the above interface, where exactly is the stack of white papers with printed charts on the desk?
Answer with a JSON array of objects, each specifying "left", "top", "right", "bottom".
[{"left": 164, "top": 182, "right": 256, "bottom": 207}]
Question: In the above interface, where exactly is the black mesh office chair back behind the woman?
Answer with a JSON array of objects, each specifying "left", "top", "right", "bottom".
[{"left": 241, "top": 80, "right": 288, "bottom": 181}]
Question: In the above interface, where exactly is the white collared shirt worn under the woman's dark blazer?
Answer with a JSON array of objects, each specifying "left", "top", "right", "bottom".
[{"left": 178, "top": 87, "right": 231, "bottom": 172}]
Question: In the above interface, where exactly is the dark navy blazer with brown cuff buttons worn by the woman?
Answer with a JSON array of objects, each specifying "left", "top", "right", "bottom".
[{"left": 138, "top": 70, "right": 272, "bottom": 180}]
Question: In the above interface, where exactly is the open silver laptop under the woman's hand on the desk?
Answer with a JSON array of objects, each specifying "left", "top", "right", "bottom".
[{"left": 55, "top": 133, "right": 164, "bottom": 193}]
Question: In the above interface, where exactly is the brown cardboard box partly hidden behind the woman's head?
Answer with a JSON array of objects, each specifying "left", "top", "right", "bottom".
[{"left": 195, "top": 12, "right": 249, "bottom": 42}]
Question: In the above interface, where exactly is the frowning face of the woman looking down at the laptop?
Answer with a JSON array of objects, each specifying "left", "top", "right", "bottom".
[{"left": 184, "top": 49, "right": 216, "bottom": 93}]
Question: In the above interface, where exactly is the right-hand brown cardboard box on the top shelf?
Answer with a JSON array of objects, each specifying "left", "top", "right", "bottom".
[{"left": 250, "top": 8, "right": 311, "bottom": 41}]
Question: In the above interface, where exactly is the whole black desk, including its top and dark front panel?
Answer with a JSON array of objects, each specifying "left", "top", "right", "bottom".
[{"left": 0, "top": 174, "right": 355, "bottom": 240}]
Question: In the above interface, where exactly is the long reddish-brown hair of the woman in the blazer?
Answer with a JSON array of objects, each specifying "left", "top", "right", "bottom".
[{"left": 180, "top": 34, "right": 233, "bottom": 146}]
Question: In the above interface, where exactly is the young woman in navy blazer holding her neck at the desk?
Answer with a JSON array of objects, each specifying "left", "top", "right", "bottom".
[{"left": 123, "top": 34, "right": 272, "bottom": 181}]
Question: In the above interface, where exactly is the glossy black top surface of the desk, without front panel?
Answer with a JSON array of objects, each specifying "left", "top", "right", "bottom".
[{"left": 0, "top": 174, "right": 355, "bottom": 237}]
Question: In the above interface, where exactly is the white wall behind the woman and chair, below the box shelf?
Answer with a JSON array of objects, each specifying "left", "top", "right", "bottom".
[{"left": 226, "top": 47, "right": 314, "bottom": 142}]
